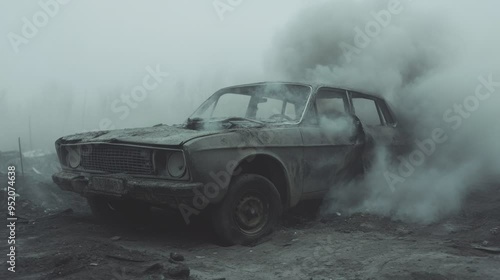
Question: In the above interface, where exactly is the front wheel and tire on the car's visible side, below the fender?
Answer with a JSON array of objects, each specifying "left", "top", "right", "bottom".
[{"left": 212, "top": 174, "right": 283, "bottom": 246}]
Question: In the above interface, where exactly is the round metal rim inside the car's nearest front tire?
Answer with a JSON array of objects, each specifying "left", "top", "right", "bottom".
[{"left": 234, "top": 192, "right": 269, "bottom": 234}]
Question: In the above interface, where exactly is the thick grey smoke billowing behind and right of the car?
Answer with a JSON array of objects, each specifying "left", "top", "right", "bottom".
[{"left": 267, "top": 0, "right": 500, "bottom": 223}]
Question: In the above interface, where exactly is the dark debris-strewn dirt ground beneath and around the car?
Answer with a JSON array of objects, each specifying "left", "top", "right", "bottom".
[{"left": 0, "top": 156, "right": 500, "bottom": 280}]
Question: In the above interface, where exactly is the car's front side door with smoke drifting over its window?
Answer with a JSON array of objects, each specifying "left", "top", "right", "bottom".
[{"left": 300, "top": 87, "right": 361, "bottom": 195}]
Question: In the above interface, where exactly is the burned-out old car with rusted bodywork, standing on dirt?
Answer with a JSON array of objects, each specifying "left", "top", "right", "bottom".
[{"left": 53, "top": 82, "right": 400, "bottom": 244}]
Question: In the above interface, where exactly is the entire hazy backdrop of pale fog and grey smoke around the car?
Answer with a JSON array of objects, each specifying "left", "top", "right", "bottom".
[{"left": 0, "top": 0, "right": 500, "bottom": 223}]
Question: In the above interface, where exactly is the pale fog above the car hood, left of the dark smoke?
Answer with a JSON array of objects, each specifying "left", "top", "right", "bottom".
[{"left": 0, "top": 0, "right": 301, "bottom": 151}]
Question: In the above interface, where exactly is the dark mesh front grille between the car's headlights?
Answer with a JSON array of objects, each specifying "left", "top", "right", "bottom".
[{"left": 80, "top": 144, "right": 154, "bottom": 175}]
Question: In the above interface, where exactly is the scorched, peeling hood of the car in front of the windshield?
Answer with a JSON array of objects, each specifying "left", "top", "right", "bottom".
[{"left": 58, "top": 125, "right": 222, "bottom": 146}]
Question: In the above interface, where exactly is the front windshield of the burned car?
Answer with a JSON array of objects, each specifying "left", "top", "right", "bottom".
[{"left": 190, "top": 84, "right": 311, "bottom": 123}]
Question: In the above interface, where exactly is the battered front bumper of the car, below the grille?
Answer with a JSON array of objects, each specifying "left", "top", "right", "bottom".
[{"left": 52, "top": 171, "right": 203, "bottom": 207}]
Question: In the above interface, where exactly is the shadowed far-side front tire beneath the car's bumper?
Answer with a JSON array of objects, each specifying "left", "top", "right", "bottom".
[{"left": 87, "top": 197, "right": 151, "bottom": 222}]
